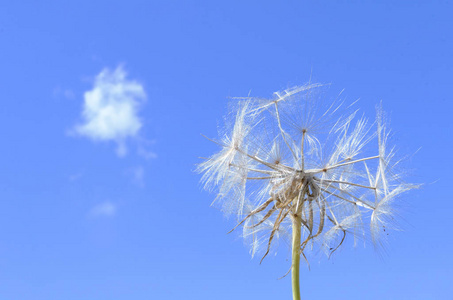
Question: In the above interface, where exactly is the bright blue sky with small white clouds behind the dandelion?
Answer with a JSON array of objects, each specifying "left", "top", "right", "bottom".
[{"left": 0, "top": 1, "right": 453, "bottom": 300}]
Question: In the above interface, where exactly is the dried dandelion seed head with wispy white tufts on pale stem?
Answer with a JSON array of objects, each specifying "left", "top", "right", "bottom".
[{"left": 197, "top": 83, "right": 417, "bottom": 300}]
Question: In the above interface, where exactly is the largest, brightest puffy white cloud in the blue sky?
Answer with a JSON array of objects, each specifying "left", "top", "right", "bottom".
[{"left": 74, "top": 66, "right": 146, "bottom": 156}]
